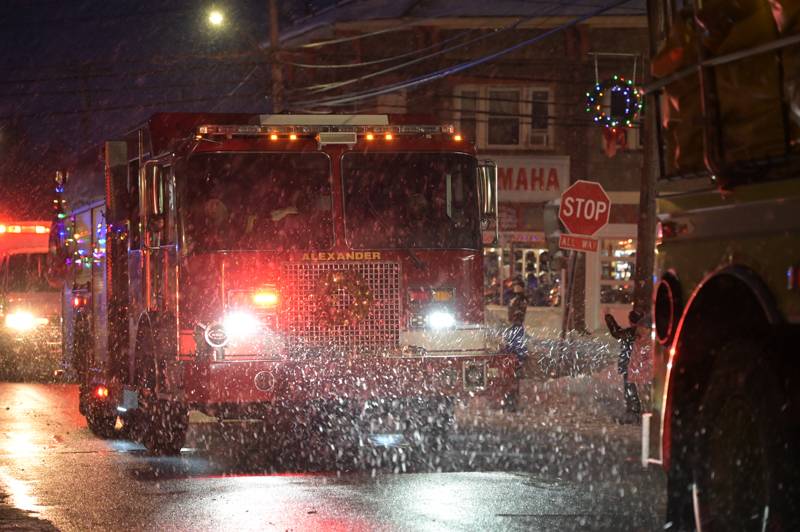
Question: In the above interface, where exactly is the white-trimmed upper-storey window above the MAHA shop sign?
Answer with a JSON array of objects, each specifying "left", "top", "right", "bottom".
[{"left": 454, "top": 85, "right": 554, "bottom": 149}]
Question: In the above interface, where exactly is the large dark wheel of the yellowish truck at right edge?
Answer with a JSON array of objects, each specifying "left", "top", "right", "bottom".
[{"left": 687, "top": 340, "right": 798, "bottom": 531}]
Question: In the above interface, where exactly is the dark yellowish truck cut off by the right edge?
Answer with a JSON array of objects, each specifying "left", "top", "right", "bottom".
[{"left": 643, "top": 0, "right": 800, "bottom": 530}]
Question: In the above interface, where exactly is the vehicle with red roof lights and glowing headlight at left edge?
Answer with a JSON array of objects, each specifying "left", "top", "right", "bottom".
[{"left": 0, "top": 221, "right": 61, "bottom": 380}]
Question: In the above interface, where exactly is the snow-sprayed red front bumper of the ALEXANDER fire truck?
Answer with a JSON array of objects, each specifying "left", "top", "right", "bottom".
[{"left": 181, "top": 354, "right": 518, "bottom": 411}]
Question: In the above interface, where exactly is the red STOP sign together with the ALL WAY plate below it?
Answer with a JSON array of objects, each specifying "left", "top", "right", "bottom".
[{"left": 558, "top": 180, "right": 611, "bottom": 251}]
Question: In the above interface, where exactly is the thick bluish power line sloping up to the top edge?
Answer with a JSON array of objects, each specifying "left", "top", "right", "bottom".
[{"left": 295, "top": 0, "right": 630, "bottom": 107}]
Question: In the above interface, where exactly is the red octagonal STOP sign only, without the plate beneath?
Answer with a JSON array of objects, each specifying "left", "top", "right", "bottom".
[{"left": 558, "top": 180, "right": 611, "bottom": 236}]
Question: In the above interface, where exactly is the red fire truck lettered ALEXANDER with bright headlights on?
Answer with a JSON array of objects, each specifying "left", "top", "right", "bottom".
[{"left": 51, "top": 113, "right": 517, "bottom": 453}]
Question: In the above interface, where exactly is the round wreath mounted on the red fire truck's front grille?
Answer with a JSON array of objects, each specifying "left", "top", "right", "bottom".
[{"left": 315, "top": 270, "right": 373, "bottom": 327}]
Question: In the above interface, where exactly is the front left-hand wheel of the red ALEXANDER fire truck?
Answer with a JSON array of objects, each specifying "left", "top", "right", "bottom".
[{"left": 141, "top": 399, "right": 189, "bottom": 456}]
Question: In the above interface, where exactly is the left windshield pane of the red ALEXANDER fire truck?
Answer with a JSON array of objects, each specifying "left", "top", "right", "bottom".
[{"left": 176, "top": 153, "right": 333, "bottom": 252}]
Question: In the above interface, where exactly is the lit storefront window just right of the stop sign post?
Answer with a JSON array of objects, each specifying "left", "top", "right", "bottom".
[{"left": 600, "top": 238, "right": 636, "bottom": 305}]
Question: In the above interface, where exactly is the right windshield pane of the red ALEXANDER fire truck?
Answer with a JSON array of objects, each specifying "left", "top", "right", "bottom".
[{"left": 342, "top": 153, "right": 480, "bottom": 249}]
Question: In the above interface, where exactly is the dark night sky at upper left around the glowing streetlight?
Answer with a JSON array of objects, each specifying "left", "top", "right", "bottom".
[{"left": 0, "top": 0, "right": 332, "bottom": 219}]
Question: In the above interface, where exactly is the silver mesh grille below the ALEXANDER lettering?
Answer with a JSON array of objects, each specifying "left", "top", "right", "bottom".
[{"left": 283, "top": 262, "right": 400, "bottom": 351}]
